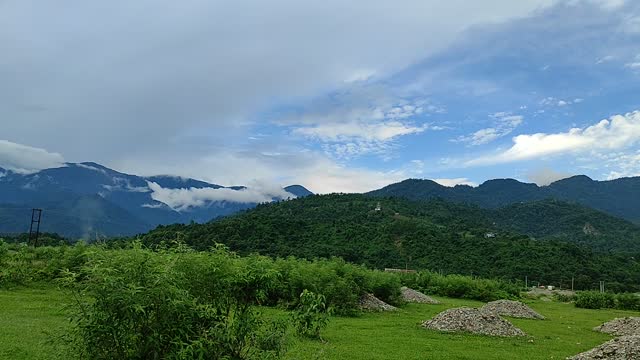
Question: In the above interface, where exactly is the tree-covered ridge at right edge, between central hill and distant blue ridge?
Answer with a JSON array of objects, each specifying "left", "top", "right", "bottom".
[{"left": 489, "top": 199, "right": 640, "bottom": 253}]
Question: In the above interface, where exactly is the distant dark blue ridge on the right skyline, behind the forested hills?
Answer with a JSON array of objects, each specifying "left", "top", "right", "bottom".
[{"left": 369, "top": 175, "right": 640, "bottom": 223}]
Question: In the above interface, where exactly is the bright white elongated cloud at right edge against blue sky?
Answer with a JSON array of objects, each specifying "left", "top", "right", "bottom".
[{"left": 466, "top": 111, "right": 640, "bottom": 166}]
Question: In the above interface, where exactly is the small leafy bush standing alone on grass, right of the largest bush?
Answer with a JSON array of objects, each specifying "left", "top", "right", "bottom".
[{"left": 292, "top": 289, "right": 330, "bottom": 339}]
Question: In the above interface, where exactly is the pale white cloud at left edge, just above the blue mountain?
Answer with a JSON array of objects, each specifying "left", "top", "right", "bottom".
[{"left": 0, "top": 140, "right": 65, "bottom": 174}]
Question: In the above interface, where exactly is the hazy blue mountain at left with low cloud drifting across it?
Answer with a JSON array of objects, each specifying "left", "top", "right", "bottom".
[{"left": 0, "top": 162, "right": 312, "bottom": 239}]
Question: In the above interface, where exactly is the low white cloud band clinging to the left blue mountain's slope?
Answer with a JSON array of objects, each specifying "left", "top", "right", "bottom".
[{"left": 147, "top": 182, "right": 295, "bottom": 211}]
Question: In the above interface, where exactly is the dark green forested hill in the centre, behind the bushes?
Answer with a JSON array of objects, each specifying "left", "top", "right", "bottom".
[{"left": 141, "top": 194, "right": 640, "bottom": 287}]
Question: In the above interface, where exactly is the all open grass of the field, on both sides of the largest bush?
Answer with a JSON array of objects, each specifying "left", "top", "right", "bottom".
[{"left": 0, "top": 289, "right": 638, "bottom": 360}]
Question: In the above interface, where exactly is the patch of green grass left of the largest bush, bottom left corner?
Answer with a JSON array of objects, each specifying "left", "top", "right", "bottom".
[{"left": 0, "top": 287, "right": 69, "bottom": 360}]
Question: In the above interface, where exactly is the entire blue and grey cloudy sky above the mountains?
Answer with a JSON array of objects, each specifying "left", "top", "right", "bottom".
[{"left": 0, "top": 0, "right": 640, "bottom": 193}]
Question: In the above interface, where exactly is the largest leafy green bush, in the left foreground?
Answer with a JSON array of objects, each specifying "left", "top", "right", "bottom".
[{"left": 66, "top": 248, "right": 284, "bottom": 359}]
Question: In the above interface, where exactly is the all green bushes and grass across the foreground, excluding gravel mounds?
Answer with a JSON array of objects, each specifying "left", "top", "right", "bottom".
[{"left": 0, "top": 241, "right": 637, "bottom": 359}]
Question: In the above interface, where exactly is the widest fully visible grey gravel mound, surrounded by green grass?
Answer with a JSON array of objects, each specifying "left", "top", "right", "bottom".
[{"left": 422, "top": 307, "right": 526, "bottom": 336}]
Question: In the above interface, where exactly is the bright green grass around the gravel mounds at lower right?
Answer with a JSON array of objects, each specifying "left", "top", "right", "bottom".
[{"left": 287, "top": 298, "right": 638, "bottom": 360}]
